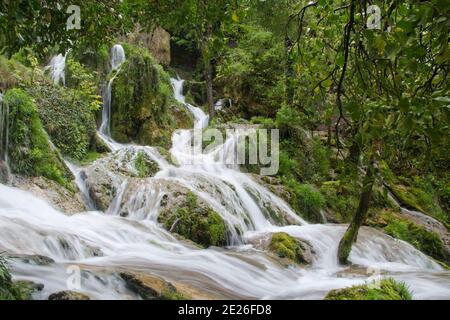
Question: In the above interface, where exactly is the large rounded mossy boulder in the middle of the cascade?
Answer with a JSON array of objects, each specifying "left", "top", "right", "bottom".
[{"left": 158, "top": 192, "right": 227, "bottom": 248}]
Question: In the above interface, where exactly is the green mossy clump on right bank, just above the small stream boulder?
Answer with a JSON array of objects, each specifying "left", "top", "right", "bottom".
[{"left": 284, "top": 179, "right": 325, "bottom": 222}]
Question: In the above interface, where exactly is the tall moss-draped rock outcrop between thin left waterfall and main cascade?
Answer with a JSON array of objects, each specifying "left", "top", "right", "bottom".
[{"left": 111, "top": 45, "right": 193, "bottom": 149}]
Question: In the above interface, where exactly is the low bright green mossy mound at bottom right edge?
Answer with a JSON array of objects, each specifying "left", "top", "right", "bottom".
[{"left": 325, "top": 279, "right": 412, "bottom": 300}]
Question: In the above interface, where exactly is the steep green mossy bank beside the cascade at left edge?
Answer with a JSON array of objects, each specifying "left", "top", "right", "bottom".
[{"left": 4, "top": 89, "right": 73, "bottom": 189}]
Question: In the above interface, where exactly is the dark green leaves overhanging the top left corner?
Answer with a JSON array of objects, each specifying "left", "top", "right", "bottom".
[{"left": 0, "top": 0, "right": 131, "bottom": 56}]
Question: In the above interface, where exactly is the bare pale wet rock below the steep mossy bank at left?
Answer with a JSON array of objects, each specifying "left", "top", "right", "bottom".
[{"left": 13, "top": 176, "right": 86, "bottom": 214}]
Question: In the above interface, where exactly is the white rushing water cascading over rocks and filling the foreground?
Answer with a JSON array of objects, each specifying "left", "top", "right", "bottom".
[{"left": 0, "top": 47, "right": 450, "bottom": 299}]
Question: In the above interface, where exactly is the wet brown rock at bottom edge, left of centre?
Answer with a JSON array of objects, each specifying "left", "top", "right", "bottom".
[{"left": 120, "top": 272, "right": 190, "bottom": 300}]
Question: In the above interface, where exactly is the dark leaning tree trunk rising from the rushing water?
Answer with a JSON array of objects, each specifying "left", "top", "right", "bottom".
[{"left": 338, "top": 162, "right": 375, "bottom": 264}]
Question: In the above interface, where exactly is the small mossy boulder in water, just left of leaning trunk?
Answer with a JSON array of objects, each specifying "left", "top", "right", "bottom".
[{"left": 268, "top": 232, "right": 313, "bottom": 264}]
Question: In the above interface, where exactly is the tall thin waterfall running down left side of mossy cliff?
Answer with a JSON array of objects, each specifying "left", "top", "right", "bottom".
[{"left": 99, "top": 44, "right": 125, "bottom": 138}]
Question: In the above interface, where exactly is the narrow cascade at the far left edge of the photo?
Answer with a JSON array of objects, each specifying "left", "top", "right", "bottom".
[{"left": 0, "top": 93, "right": 11, "bottom": 184}]
